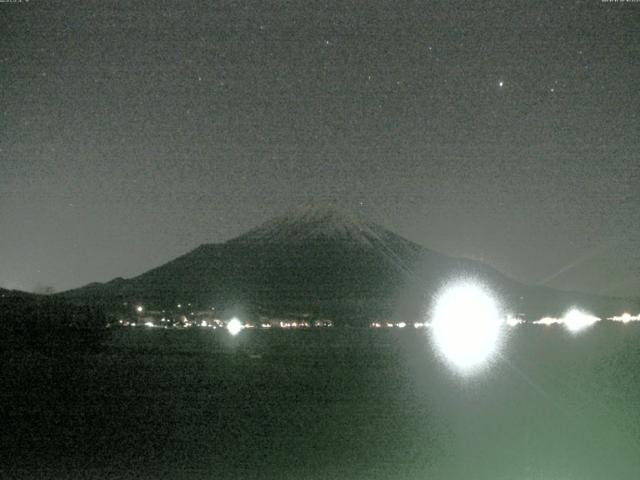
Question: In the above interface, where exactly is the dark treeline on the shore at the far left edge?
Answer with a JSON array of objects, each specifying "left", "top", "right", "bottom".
[{"left": 0, "top": 291, "right": 107, "bottom": 355}]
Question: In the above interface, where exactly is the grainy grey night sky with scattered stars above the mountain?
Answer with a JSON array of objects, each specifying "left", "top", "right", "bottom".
[{"left": 0, "top": 0, "right": 640, "bottom": 296}]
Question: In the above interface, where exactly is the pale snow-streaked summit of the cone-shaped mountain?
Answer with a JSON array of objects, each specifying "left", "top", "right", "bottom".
[{"left": 235, "top": 205, "right": 384, "bottom": 245}]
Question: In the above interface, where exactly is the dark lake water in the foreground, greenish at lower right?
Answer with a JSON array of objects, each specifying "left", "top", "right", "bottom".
[{"left": 0, "top": 324, "right": 640, "bottom": 480}]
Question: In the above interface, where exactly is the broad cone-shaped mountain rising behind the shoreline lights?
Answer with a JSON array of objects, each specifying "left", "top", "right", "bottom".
[{"left": 59, "top": 207, "right": 639, "bottom": 323}]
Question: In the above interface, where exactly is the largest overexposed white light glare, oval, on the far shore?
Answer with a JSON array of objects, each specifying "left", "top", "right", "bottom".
[{"left": 432, "top": 283, "right": 504, "bottom": 370}]
